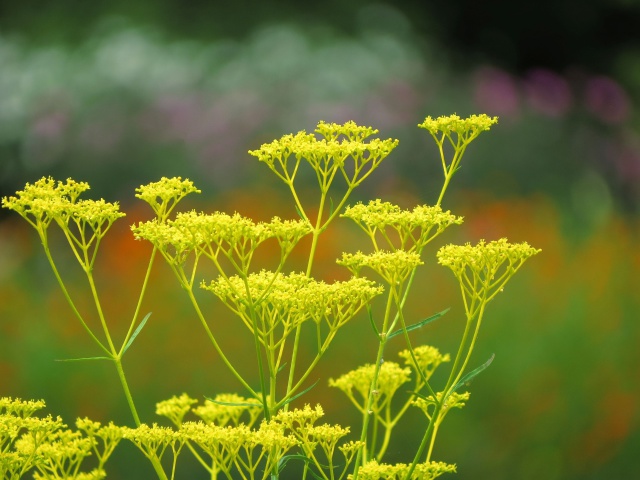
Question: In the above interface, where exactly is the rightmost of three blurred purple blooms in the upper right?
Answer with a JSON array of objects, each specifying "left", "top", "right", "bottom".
[{"left": 585, "top": 76, "right": 631, "bottom": 124}]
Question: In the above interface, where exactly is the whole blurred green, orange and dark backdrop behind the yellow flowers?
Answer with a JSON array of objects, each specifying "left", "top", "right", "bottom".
[{"left": 0, "top": 0, "right": 640, "bottom": 480}]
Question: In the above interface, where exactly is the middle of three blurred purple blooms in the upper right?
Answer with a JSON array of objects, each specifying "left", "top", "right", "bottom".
[{"left": 524, "top": 69, "right": 573, "bottom": 117}]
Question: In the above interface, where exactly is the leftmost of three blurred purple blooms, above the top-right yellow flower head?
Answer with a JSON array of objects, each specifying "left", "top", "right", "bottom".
[{"left": 473, "top": 67, "right": 520, "bottom": 116}]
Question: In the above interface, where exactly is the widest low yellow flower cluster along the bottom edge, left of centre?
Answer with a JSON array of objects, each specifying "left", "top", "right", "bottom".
[{"left": 152, "top": 402, "right": 361, "bottom": 478}]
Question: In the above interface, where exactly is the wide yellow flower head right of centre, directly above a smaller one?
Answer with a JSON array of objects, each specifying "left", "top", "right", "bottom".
[{"left": 341, "top": 199, "right": 463, "bottom": 252}]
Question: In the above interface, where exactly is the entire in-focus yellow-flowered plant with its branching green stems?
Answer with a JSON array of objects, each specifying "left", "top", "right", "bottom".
[{"left": 0, "top": 115, "right": 539, "bottom": 480}]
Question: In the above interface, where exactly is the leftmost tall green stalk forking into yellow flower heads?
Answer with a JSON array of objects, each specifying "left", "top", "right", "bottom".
[{"left": 2, "top": 178, "right": 198, "bottom": 479}]
